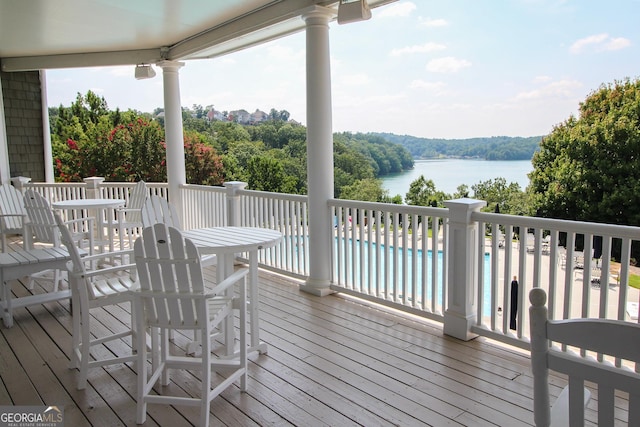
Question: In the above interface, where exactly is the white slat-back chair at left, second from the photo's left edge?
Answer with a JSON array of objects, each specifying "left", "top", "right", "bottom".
[{"left": 24, "top": 190, "right": 94, "bottom": 292}]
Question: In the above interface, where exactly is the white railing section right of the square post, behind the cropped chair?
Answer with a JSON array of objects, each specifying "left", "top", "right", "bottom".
[{"left": 471, "top": 212, "right": 640, "bottom": 352}]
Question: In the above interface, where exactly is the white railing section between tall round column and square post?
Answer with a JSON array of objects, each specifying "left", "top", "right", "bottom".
[{"left": 330, "top": 200, "right": 449, "bottom": 321}]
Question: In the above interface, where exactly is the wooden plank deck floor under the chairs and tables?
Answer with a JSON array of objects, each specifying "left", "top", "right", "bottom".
[{"left": 0, "top": 237, "right": 544, "bottom": 427}]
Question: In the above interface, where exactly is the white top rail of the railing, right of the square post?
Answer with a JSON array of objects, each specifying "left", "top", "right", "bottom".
[{"left": 478, "top": 212, "right": 640, "bottom": 240}]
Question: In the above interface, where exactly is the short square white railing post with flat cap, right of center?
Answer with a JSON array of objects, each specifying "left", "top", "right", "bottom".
[{"left": 443, "top": 198, "right": 487, "bottom": 341}]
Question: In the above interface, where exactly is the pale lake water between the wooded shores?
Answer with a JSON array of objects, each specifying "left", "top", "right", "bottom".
[{"left": 382, "top": 159, "right": 533, "bottom": 199}]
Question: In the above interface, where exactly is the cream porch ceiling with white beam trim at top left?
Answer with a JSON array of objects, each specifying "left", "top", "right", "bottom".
[{"left": 0, "top": 0, "right": 390, "bottom": 71}]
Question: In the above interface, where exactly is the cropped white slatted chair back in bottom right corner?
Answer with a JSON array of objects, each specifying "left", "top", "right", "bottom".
[{"left": 529, "top": 288, "right": 640, "bottom": 427}]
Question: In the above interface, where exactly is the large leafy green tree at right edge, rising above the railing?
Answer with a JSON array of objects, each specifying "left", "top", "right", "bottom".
[{"left": 529, "top": 79, "right": 640, "bottom": 225}]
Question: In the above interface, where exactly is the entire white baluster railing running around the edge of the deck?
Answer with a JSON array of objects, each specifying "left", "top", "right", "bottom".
[{"left": 15, "top": 181, "right": 640, "bottom": 348}]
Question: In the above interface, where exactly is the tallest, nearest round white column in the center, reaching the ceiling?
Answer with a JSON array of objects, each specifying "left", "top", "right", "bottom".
[{"left": 300, "top": 7, "right": 335, "bottom": 296}]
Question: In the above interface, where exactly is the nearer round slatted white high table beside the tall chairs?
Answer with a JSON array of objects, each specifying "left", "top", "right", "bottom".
[{"left": 182, "top": 227, "right": 282, "bottom": 355}]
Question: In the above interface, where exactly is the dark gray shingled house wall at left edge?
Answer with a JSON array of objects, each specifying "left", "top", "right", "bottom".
[{"left": 0, "top": 71, "right": 45, "bottom": 182}]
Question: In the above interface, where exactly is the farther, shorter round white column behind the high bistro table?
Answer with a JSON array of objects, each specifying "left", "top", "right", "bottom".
[{"left": 156, "top": 61, "right": 187, "bottom": 217}]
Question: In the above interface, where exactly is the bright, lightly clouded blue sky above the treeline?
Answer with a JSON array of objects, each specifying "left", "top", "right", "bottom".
[{"left": 46, "top": 0, "right": 640, "bottom": 139}]
